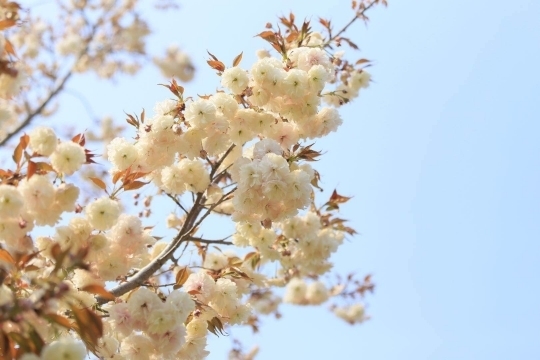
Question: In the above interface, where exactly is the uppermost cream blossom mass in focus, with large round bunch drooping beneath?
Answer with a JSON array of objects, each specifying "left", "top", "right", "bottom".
[{"left": 108, "top": 43, "right": 369, "bottom": 222}]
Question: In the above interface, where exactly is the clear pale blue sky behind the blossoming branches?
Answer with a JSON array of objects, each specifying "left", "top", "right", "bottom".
[{"left": 27, "top": 0, "right": 540, "bottom": 360}]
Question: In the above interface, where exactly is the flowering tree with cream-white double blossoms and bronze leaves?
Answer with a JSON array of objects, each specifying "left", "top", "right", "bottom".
[{"left": 0, "top": 0, "right": 386, "bottom": 360}]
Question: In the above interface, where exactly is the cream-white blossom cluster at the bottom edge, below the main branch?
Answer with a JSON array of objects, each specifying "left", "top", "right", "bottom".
[{"left": 98, "top": 254, "right": 258, "bottom": 360}]
